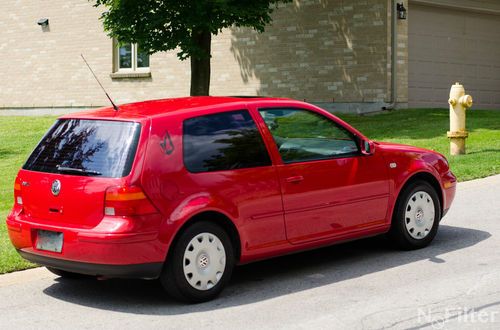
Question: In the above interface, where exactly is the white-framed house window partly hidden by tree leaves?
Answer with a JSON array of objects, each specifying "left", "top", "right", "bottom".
[{"left": 113, "top": 41, "right": 149, "bottom": 73}]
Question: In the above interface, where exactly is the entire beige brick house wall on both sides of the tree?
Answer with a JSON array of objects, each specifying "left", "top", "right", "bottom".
[{"left": 0, "top": 0, "right": 396, "bottom": 108}]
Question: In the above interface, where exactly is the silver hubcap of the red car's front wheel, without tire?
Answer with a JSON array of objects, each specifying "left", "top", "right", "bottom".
[{"left": 405, "top": 191, "right": 435, "bottom": 239}]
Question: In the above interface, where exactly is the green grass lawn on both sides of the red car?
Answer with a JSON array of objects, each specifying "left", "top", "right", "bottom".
[{"left": 0, "top": 109, "right": 500, "bottom": 274}]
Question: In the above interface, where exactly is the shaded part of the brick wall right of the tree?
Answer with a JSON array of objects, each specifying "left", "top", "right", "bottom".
[{"left": 231, "top": 0, "right": 388, "bottom": 102}]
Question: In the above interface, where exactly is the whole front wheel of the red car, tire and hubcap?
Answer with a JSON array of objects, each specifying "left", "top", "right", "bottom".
[{"left": 389, "top": 181, "right": 441, "bottom": 250}]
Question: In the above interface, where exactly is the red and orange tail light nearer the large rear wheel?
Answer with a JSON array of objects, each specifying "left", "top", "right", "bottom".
[{"left": 104, "top": 186, "right": 158, "bottom": 216}]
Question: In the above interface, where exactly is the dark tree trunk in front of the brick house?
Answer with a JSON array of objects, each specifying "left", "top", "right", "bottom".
[{"left": 191, "top": 31, "right": 212, "bottom": 96}]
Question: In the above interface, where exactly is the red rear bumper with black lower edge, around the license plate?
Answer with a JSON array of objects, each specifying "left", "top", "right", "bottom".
[{"left": 6, "top": 212, "right": 167, "bottom": 278}]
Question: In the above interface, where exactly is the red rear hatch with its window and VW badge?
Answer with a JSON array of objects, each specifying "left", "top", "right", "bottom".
[{"left": 18, "top": 119, "right": 141, "bottom": 228}]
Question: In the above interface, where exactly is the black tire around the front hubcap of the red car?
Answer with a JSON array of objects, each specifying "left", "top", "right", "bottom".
[{"left": 388, "top": 181, "right": 441, "bottom": 250}]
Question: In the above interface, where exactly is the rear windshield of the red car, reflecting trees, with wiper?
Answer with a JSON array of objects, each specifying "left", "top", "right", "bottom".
[{"left": 23, "top": 119, "right": 141, "bottom": 178}]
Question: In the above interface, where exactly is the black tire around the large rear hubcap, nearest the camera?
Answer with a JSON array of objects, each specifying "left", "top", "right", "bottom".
[{"left": 160, "top": 221, "right": 235, "bottom": 303}]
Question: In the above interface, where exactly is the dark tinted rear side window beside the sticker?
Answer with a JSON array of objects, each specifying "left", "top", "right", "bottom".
[{"left": 183, "top": 110, "right": 271, "bottom": 173}]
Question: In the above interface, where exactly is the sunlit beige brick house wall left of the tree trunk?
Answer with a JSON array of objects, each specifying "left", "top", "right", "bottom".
[{"left": 0, "top": 0, "right": 189, "bottom": 108}]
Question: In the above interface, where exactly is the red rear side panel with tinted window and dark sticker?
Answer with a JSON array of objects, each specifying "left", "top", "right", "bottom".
[{"left": 142, "top": 106, "right": 288, "bottom": 258}]
